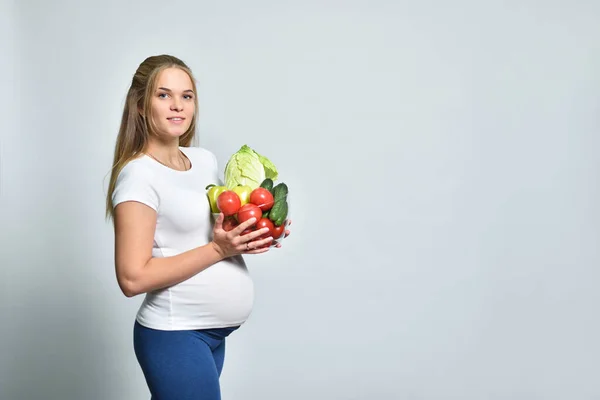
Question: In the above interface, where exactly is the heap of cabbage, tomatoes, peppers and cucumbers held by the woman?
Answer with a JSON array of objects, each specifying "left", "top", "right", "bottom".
[{"left": 206, "top": 145, "right": 290, "bottom": 247}]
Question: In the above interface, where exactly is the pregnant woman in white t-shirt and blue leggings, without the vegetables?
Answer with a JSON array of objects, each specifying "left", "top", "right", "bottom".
[{"left": 106, "top": 55, "right": 289, "bottom": 400}]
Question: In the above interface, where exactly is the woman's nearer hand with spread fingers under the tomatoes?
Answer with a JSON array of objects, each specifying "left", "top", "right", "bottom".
[{"left": 211, "top": 213, "right": 273, "bottom": 258}]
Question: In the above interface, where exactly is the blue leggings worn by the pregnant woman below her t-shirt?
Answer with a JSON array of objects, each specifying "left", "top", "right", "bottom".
[{"left": 133, "top": 321, "right": 238, "bottom": 400}]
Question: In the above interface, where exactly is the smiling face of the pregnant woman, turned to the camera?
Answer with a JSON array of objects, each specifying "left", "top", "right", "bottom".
[{"left": 151, "top": 68, "right": 196, "bottom": 138}]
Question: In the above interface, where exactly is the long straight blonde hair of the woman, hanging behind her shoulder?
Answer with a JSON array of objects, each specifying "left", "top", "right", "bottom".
[{"left": 106, "top": 55, "right": 198, "bottom": 218}]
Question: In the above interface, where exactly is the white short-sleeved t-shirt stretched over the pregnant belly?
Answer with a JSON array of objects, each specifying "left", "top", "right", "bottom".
[{"left": 113, "top": 147, "right": 254, "bottom": 330}]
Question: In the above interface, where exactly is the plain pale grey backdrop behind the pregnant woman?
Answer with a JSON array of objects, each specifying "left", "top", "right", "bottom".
[{"left": 0, "top": 0, "right": 600, "bottom": 400}]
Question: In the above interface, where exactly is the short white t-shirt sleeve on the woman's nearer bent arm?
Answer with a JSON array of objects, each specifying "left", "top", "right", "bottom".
[{"left": 112, "top": 164, "right": 159, "bottom": 211}]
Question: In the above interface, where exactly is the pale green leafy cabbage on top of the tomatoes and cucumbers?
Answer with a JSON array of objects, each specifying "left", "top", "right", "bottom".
[{"left": 225, "top": 145, "right": 278, "bottom": 189}]
